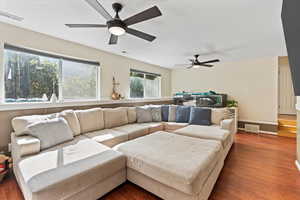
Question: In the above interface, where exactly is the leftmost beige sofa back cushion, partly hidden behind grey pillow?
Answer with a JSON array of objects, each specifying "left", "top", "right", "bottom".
[{"left": 12, "top": 114, "right": 56, "bottom": 136}]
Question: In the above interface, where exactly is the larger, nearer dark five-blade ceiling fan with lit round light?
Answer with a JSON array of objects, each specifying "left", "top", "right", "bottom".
[{"left": 65, "top": 0, "right": 162, "bottom": 45}]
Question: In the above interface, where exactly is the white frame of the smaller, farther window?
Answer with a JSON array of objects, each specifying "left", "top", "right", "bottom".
[{"left": 129, "top": 69, "right": 162, "bottom": 99}]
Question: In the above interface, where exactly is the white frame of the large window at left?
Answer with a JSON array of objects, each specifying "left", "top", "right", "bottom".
[{"left": 0, "top": 43, "right": 101, "bottom": 105}]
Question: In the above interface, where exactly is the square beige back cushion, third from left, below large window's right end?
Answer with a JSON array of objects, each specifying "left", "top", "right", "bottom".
[{"left": 75, "top": 108, "right": 104, "bottom": 133}]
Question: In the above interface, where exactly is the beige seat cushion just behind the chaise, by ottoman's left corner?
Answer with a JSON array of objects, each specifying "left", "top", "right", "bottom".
[{"left": 84, "top": 129, "right": 128, "bottom": 147}]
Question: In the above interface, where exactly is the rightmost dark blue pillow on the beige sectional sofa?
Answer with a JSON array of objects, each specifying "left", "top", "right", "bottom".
[{"left": 189, "top": 107, "right": 211, "bottom": 126}]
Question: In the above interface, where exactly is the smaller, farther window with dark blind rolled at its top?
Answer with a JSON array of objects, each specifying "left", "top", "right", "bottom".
[{"left": 130, "top": 69, "right": 161, "bottom": 98}]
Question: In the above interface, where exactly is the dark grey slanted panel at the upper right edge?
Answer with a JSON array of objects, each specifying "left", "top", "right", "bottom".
[{"left": 281, "top": 0, "right": 300, "bottom": 96}]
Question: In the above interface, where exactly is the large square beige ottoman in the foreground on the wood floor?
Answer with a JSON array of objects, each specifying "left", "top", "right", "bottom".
[{"left": 114, "top": 131, "right": 223, "bottom": 200}]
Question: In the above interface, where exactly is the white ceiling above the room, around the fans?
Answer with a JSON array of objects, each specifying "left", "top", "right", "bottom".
[{"left": 0, "top": 0, "right": 287, "bottom": 68}]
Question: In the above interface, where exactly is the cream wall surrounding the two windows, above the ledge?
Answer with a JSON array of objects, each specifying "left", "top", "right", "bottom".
[{"left": 0, "top": 22, "right": 171, "bottom": 99}]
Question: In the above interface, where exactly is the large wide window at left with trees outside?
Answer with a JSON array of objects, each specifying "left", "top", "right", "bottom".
[{"left": 4, "top": 45, "right": 99, "bottom": 103}]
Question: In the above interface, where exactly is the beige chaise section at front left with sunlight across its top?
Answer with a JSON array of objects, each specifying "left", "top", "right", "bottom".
[{"left": 17, "top": 139, "right": 126, "bottom": 199}]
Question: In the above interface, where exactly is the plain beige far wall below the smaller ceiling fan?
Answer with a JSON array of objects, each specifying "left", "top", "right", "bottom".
[{"left": 171, "top": 57, "right": 278, "bottom": 123}]
